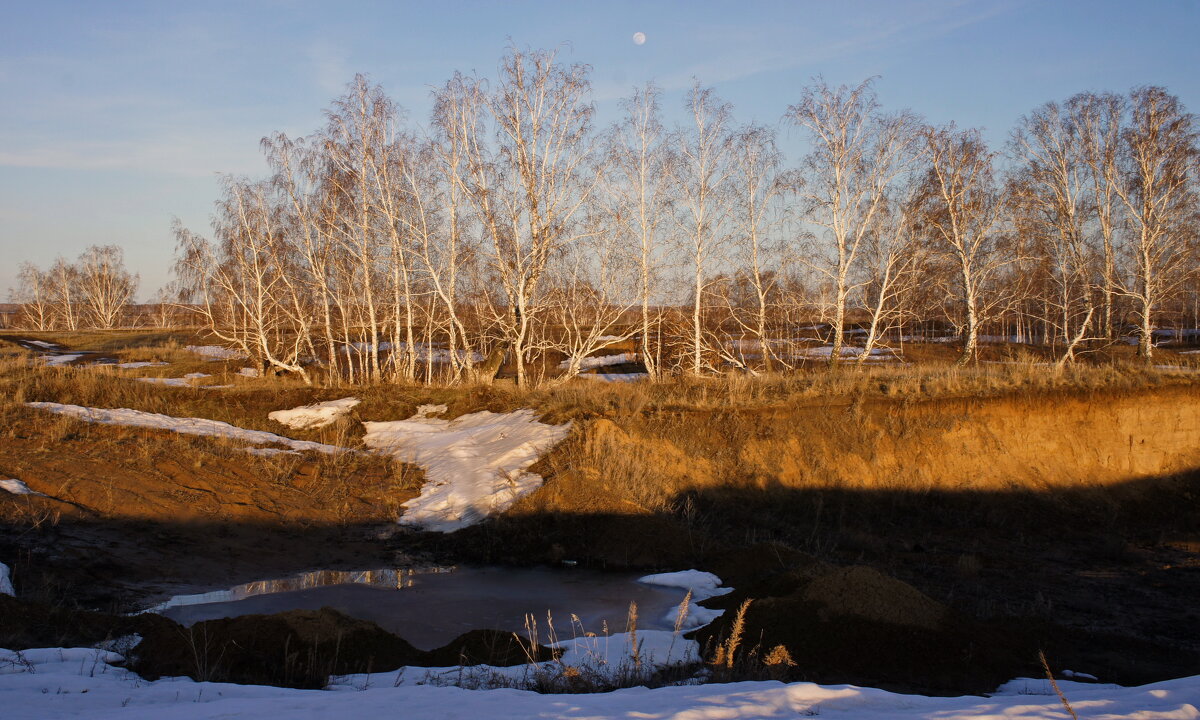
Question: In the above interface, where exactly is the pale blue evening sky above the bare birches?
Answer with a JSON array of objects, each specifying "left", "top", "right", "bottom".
[{"left": 0, "top": 0, "right": 1200, "bottom": 299}]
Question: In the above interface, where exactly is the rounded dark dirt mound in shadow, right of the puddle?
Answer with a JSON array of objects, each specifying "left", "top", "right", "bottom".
[{"left": 694, "top": 566, "right": 1036, "bottom": 694}]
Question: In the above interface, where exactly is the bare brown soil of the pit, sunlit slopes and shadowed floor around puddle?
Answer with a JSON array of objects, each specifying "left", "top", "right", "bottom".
[{"left": 0, "top": 333, "right": 1200, "bottom": 692}]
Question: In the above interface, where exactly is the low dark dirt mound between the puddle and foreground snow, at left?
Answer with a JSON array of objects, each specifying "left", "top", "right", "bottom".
[{"left": 132, "top": 607, "right": 425, "bottom": 688}]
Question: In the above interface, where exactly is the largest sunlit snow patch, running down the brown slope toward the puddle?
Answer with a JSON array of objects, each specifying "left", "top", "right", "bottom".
[{"left": 362, "top": 406, "right": 570, "bottom": 533}]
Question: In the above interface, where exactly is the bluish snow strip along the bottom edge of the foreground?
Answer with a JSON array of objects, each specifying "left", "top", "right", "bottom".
[{"left": 0, "top": 648, "right": 1200, "bottom": 720}]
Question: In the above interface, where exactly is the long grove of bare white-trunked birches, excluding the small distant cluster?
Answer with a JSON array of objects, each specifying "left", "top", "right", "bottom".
[{"left": 11, "top": 48, "right": 1200, "bottom": 384}]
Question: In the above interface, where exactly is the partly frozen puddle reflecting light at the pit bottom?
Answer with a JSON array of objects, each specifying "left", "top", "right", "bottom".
[{"left": 149, "top": 566, "right": 685, "bottom": 650}]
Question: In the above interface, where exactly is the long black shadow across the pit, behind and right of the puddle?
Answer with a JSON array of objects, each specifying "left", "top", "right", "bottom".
[{"left": 0, "top": 473, "right": 1200, "bottom": 691}]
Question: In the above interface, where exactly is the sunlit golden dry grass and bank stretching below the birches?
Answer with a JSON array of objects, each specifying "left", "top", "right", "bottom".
[{"left": 0, "top": 332, "right": 1198, "bottom": 526}]
